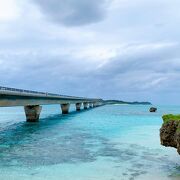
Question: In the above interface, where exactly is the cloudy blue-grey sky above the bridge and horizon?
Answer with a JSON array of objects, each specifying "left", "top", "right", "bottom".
[{"left": 0, "top": 0, "right": 180, "bottom": 104}]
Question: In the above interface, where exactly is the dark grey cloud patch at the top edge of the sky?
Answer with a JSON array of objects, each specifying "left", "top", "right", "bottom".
[{"left": 34, "top": 0, "right": 106, "bottom": 26}]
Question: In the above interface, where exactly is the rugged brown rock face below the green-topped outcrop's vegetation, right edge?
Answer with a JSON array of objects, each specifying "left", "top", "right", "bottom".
[{"left": 160, "top": 116, "right": 180, "bottom": 154}]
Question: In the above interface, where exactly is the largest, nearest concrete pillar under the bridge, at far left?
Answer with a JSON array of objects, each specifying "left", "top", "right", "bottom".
[{"left": 24, "top": 105, "right": 42, "bottom": 122}]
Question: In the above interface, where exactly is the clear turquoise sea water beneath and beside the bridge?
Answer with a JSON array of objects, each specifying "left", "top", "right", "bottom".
[{"left": 0, "top": 105, "right": 180, "bottom": 180}]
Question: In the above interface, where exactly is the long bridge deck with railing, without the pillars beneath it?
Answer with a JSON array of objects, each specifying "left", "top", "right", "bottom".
[{"left": 0, "top": 87, "right": 102, "bottom": 107}]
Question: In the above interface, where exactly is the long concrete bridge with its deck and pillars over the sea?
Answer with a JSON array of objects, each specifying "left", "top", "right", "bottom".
[{"left": 0, "top": 87, "right": 104, "bottom": 122}]
